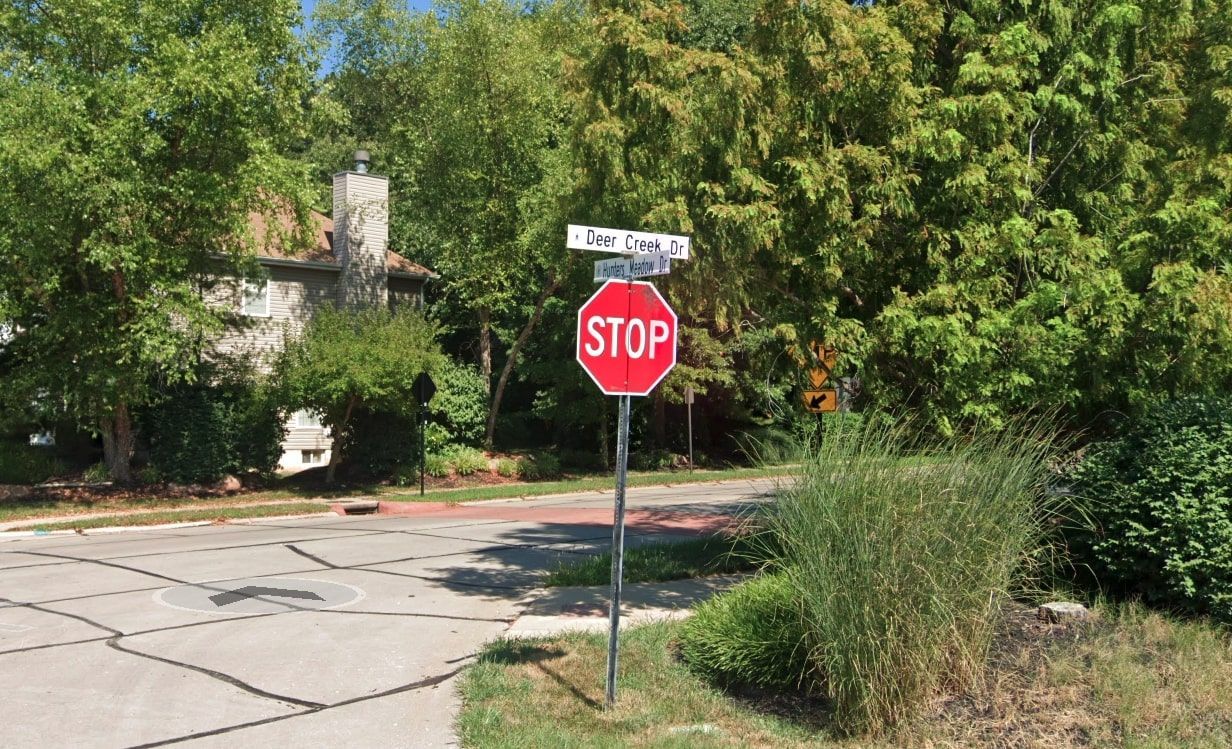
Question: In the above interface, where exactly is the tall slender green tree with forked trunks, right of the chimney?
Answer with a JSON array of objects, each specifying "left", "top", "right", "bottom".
[{"left": 393, "top": 0, "right": 586, "bottom": 447}]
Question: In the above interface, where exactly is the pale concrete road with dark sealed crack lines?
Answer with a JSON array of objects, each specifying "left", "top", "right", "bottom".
[{"left": 0, "top": 480, "right": 770, "bottom": 747}]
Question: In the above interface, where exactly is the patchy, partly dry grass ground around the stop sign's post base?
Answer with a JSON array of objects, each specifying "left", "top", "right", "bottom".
[{"left": 458, "top": 606, "right": 1232, "bottom": 749}]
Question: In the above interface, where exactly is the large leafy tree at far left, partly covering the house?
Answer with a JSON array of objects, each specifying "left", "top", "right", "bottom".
[{"left": 0, "top": 0, "right": 309, "bottom": 482}]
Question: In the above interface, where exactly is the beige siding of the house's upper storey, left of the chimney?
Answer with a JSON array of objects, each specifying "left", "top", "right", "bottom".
[{"left": 211, "top": 266, "right": 338, "bottom": 371}]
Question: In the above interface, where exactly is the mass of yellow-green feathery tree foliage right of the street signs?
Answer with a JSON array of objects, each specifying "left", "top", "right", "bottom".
[{"left": 572, "top": 0, "right": 1232, "bottom": 430}]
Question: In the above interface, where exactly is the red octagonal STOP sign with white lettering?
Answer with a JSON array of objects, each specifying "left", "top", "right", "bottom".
[{"left": 578, "top": 280, "right": 676, "bottom": 395}]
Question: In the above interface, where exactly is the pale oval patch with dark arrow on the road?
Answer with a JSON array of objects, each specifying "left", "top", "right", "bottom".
[{"left": 154, "top": 578, "right": 363, "bottom": 613}]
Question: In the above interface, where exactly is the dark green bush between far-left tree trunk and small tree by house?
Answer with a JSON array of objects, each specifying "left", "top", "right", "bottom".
[{"left": 142, "top": 368, "right": 285, "bottom": 483}]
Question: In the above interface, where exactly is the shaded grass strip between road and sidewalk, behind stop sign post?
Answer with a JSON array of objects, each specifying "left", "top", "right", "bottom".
[{"left": 543, "top": 536, "right": 760, "bottom": 588}]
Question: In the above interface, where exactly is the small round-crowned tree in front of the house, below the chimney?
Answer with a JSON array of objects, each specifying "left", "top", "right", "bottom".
[{"left": 275, "top": 308, "right": 445, "bottom": 483}]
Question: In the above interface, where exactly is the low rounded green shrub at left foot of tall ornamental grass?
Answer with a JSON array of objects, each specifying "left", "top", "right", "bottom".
[{"left": 680, "top": 573, "right": 818, "bottom": 690}]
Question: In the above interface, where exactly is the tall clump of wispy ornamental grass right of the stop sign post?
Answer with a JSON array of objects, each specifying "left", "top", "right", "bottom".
[{"left": 769, "top": 425, "right": 1055, "bottom": 733}]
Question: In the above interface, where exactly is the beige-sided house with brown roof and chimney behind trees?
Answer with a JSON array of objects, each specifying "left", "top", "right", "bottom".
[{"left": 212, "top": 150, "right": 439, "bottom": 471}]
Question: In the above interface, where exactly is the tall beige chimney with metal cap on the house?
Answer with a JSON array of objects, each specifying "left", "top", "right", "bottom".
[{"left": 334, "top": 150, "right": 389, "bottom": 309}]
